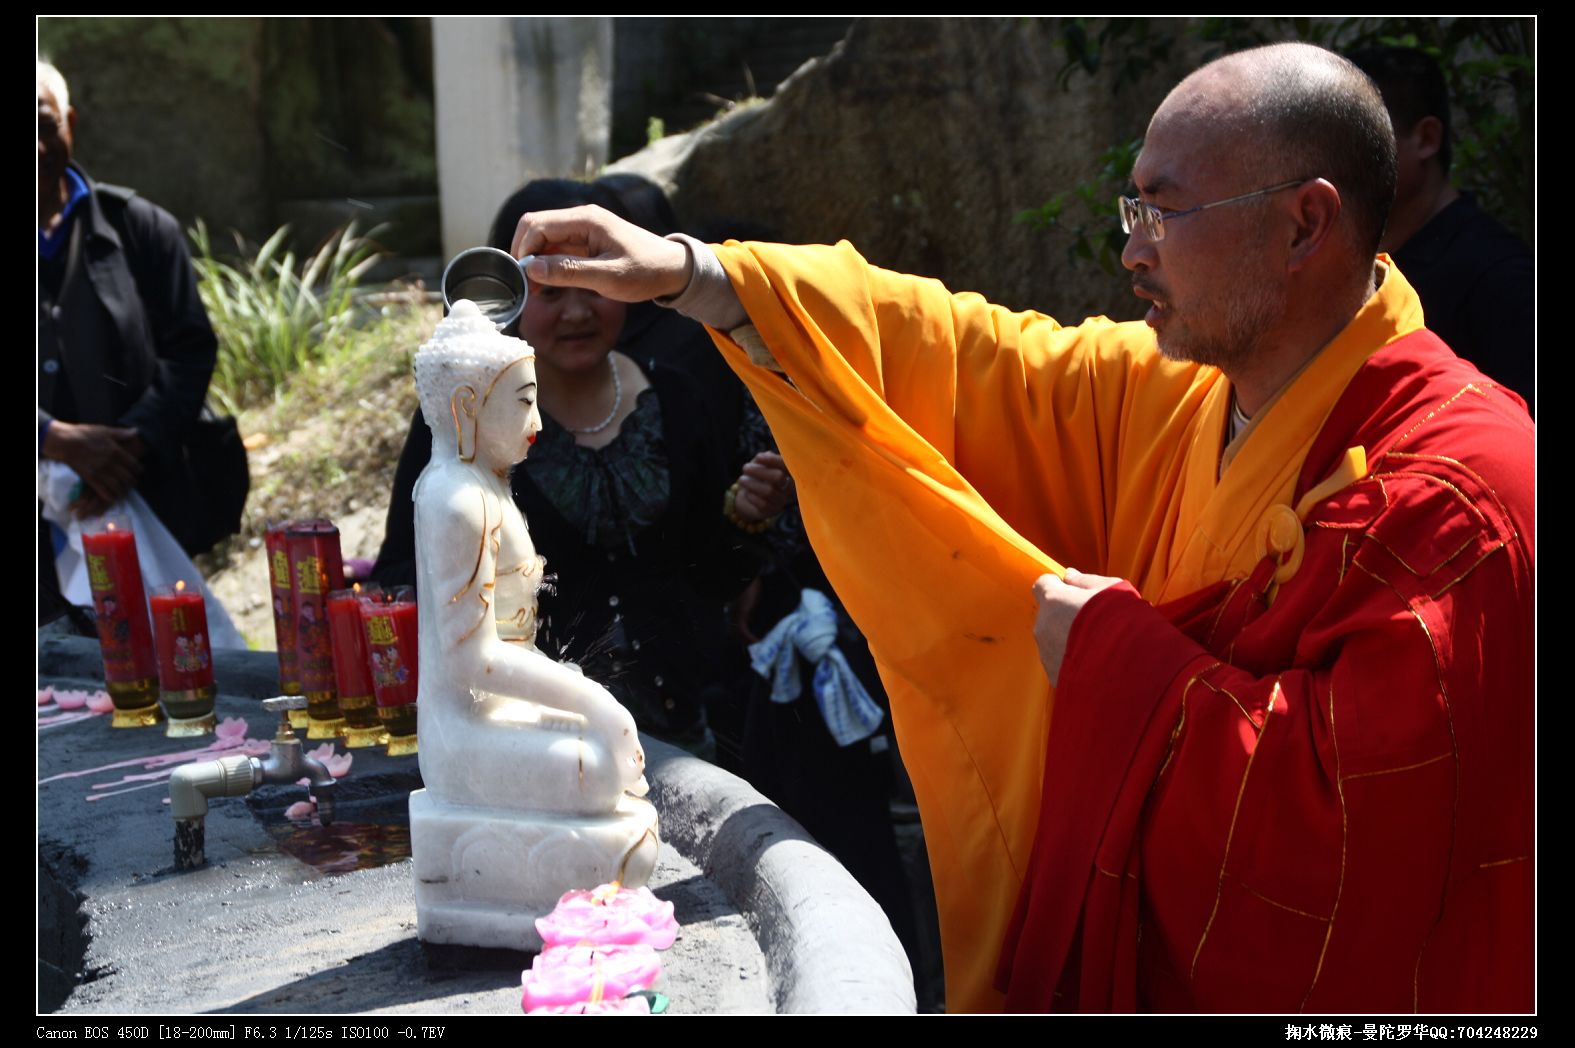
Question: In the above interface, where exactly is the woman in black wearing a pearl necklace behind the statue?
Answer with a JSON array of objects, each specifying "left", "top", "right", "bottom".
[{"left": 373, "top": 181, "right": 788, "bottom": 755}]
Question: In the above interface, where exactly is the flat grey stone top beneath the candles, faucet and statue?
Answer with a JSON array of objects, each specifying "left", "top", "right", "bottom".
[{"left": 38, "top": 681, "right": 772, "bottom": 1015}]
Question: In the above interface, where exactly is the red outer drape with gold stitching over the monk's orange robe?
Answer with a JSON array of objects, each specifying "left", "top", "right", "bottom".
[{"left": 1002, "top": 331, "right": 1534, "bottom": 1012}]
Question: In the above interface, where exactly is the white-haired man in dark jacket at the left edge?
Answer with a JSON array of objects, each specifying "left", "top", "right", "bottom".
[{"left": 38, "top": 61, "right": 217, "bottom": 614}]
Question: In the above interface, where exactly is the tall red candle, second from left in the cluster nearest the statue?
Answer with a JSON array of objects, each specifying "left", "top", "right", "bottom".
[{"left": 285, "top": 520, "right": 345, "bottom": 739}]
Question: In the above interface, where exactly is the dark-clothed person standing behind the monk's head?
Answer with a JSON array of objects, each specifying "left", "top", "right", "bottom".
[{"left": 1347, "top": 47, "right": 1536, "bottom": 408}]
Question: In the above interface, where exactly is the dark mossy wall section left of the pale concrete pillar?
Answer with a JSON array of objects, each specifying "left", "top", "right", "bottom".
[{"left": 38, "top": 17, "right": 438, "bottom": 254}]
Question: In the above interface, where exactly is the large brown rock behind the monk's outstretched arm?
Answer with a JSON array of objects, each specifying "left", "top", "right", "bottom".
[{"left": 610, "top": 19, "right": 1197, "bottom": 321}]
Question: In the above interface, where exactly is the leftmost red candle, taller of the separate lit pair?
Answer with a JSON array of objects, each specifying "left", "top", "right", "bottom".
[{"left": 82, "top": 518, "right": 162, "bottom": 728}]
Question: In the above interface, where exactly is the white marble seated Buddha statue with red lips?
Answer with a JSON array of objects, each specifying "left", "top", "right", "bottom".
[{"left": 411, "top": 301, "right": 657, "bottom": 949}]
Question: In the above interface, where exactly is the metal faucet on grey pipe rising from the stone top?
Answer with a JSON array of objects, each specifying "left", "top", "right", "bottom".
[{"left": 170, "top": 695, "right": 334, "bottom": 870}]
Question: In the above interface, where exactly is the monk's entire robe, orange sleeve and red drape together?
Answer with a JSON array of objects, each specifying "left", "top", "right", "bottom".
[{"left": 717, "top": 244, "right": 1532, "bottom": 1010}]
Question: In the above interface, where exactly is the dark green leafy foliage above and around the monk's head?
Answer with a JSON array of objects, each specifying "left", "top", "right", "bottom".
[{"left": 1017, "top": 17, "right": 1536, "bottom": 273}]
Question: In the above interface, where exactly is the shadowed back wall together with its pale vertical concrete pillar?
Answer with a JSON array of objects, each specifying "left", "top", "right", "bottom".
[{"left": 38, "top": 16, "right": 849, "bottom": 266}]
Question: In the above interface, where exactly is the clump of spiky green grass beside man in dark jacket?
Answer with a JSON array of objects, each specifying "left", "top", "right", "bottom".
[{"left": 187, "top": 219, "right": 383, "bottom": 414}]
